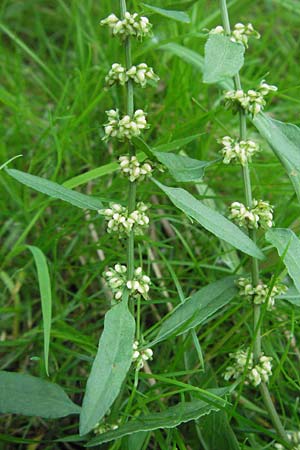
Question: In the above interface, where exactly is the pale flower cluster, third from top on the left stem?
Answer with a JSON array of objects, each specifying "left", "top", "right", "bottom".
[{"left": 103, "top": 109, "right": 147, "bottom": 141}]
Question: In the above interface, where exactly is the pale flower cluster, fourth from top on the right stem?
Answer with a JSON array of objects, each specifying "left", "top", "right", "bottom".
[{"left": 229, "top": 200, "right": 273, "bottom": 230}]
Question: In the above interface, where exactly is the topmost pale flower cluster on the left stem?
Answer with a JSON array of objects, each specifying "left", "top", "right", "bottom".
[{"left": 100, "top": 11, "right": 152, "bottom": 39}]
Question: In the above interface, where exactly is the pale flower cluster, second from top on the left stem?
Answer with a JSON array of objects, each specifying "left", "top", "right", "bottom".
[{"left": 105, "top": 63, "right": 159, "bottom": 87}]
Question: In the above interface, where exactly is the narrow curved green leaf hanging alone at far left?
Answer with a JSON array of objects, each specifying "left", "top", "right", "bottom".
[{"left": 27, "top": 245, "right": 52, "bottom": 376}]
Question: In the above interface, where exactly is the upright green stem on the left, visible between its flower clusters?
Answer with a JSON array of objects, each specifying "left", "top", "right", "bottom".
[{"left": 120, "top": 0, "right": 136, "bottom": 280}]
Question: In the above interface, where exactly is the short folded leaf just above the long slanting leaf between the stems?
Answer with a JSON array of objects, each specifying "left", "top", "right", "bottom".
[{"left": 154, "top": 152, "right": 214, "bottom": 183}]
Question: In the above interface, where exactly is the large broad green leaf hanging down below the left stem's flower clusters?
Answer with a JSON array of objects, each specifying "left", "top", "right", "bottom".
[{"left": 80, "top": 299, "right": 135, "bottom": 436}]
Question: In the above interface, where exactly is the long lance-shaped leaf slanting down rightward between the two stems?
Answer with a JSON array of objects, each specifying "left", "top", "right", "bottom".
[{"left": 153, "top": 179, "right": 264, "bottom": 259}]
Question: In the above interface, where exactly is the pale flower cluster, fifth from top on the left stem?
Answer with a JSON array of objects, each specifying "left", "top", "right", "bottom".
[{"left": 99, "top": 202, "right": 149, "bottom": 236}]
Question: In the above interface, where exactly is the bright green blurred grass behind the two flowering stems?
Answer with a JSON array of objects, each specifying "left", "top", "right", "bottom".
[{"left": 0, "top": 0, "right": 300, "bottom": 450}]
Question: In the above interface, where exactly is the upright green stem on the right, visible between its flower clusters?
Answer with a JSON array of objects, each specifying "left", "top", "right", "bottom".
[{"left": 220, "top": 0, "right": 288, "bottom": 443}]
